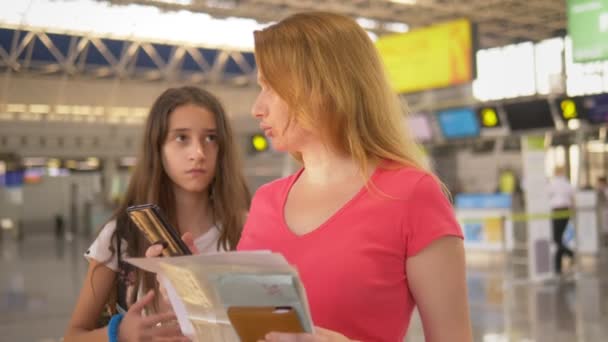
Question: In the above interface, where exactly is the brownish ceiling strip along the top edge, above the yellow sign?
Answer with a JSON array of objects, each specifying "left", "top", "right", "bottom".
[{"left": 105, "top": 0, "right": 566, "bottom": 48}]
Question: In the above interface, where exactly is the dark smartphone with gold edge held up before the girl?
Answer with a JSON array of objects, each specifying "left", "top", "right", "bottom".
[{"left": 127, "top": 204, "right": 192, "bottom": 256}]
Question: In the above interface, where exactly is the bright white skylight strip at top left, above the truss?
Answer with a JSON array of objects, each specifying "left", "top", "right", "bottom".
[{"left": 0, "top": 0, "right": 266, "bottom": 51}]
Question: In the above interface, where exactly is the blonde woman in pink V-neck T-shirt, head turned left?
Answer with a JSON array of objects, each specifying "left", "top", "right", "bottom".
[{"left": 238, "top": 12, "right": 472, "bottom": 342}]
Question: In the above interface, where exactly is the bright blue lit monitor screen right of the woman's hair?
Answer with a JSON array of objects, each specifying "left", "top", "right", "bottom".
[{"left": 437, "top": 108, "right": 479, "bottom": 139}]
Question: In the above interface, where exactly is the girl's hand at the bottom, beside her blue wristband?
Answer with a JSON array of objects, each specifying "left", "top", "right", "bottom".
[{"left": 118, "top": 291, "right": 189, "bottom": 342}]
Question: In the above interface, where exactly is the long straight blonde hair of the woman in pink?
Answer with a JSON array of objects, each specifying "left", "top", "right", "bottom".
[{"left": 254, "top": 12, "right": 429, "bottom": 175}]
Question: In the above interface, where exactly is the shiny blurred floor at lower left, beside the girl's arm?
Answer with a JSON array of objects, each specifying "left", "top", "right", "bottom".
[{"left": 0, "top": 235, "right": 87, "bottom": 341}]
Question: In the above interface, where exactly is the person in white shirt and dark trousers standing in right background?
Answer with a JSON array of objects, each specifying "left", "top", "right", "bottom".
[{"left": 549, "top": 166, "right": 574, "bottom": 275}]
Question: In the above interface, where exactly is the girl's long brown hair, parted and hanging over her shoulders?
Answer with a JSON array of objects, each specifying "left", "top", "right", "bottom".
[{"left": 97, "top": 86, "right": 251, "bottom": 312}]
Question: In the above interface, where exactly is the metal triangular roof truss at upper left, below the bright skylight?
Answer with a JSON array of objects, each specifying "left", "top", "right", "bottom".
[{"left": 0, "top": 28, "right": 256, "bottom": 86}]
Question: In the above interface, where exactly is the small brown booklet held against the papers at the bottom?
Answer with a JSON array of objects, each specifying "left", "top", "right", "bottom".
[{"left": 227, "top": 306, "right": 305, "bottom": 342}]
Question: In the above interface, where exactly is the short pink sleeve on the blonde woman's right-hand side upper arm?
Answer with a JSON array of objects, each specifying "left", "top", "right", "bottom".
[{"left": 402, "top": 175, "right": 463, "bottom": 257}]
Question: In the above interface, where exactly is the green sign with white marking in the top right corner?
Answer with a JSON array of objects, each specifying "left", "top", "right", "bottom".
[{"left": 568, "top": 0, "right": 608, "bottom": 62}]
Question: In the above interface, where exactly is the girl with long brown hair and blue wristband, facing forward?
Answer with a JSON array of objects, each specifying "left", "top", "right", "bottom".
[{"left": 64, "top": 87, "right": 250, "bottom": 342}]
